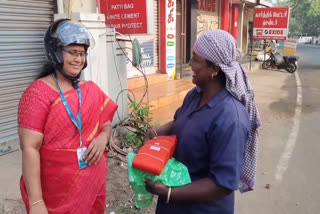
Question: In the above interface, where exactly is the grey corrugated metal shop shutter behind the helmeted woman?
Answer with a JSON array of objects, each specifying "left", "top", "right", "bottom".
[{"left": 0, "top": 0, "right": 56, "bottom": 155}]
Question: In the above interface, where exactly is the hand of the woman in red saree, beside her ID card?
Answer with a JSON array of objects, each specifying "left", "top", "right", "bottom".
[{"left": 85, "top": 133, "right": 108, "bottom": 165}]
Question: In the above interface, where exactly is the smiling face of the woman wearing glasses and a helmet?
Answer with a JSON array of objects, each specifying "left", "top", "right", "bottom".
[{"left": 62, "top": 45, "right": 87, "bottom": 77}]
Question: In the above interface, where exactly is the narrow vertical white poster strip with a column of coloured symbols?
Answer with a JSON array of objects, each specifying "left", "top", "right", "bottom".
[{"left": 166, "top": 0, "right": 176, "bottom": 80}]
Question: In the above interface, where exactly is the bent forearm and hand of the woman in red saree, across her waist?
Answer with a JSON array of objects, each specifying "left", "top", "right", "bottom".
[{"left": 85, "top": 121, "right": 112, "bottom": 165}]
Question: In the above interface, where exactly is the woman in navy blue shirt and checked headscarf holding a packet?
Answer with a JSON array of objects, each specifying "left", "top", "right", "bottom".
[{"left": 145, "top": 30, "right": 260, "bottom": 214}]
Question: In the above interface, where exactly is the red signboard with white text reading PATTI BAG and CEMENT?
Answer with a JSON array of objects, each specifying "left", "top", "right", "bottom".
[{"left": 101, "top": 0, "right": 148, "bottom": 34}]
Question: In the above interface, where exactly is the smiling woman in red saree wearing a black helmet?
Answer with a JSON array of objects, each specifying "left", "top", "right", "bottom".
[{"left": 18, "top": 20, "right": 117, "bottom": 214}]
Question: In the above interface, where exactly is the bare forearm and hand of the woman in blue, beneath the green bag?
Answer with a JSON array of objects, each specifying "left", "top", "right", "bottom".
[{"left": 145, "top": 178, "right": 233, "bottom": 202}]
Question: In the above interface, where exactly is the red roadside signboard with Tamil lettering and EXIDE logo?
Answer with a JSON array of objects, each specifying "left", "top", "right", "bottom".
[{"left": 253, "top": 7, "right": 290, "bottom": 40}]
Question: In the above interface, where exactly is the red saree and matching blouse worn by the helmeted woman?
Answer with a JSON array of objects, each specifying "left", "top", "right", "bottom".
[{"left": 18, "top": 80, "right": 117, "bottom": 214}]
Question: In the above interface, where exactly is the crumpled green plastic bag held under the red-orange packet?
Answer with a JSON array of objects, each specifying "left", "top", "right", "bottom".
[{"left": 128, "top": 153, "right": 191, "bottom": 209}]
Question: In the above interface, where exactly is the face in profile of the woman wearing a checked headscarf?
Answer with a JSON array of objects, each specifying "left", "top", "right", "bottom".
[{"left": 189, "top": 51, "right": 212, "bottom": 88}]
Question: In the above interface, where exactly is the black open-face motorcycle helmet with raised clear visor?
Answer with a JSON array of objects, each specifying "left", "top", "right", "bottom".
[{"left": 44, "top": 19, "right": 94, "bottom": 86}]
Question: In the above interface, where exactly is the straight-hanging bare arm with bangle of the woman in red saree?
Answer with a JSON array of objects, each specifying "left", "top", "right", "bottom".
[{"left": 18, "top": 128, "right": 47, "bottom": 213}]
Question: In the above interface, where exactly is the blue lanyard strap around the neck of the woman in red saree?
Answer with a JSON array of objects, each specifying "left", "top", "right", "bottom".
[{"left": 53, "top": 74, "right": 82, "bottom": 148}]
